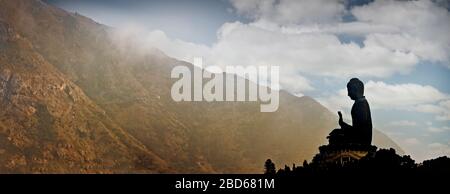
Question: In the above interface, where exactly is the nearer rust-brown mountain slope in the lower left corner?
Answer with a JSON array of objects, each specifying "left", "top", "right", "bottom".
[{"left": 0, "top": 16, "right": 168, "bottom": 173}]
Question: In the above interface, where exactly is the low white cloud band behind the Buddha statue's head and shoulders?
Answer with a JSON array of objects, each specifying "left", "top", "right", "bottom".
[{"left": 319, "top": 81, "right": 450, "bottom": 120}]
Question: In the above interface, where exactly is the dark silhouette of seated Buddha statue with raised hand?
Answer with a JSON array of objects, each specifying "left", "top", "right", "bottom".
[{"left": 327, "top": 78, "right": 372, "bottom": 145}]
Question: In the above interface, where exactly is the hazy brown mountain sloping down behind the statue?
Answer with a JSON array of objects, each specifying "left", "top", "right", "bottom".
[{"left": 0, "top": 0, "right": 400, "bottom": 173}]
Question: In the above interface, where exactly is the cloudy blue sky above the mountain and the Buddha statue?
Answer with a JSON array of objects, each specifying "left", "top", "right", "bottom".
[{"left": 46, "top": 0, "right": 450, "bottom": 162}]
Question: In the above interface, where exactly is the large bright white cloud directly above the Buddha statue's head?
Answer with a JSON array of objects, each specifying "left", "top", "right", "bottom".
[{"left": 209, "top": 22, "right": 418, "bottom": 77}]
